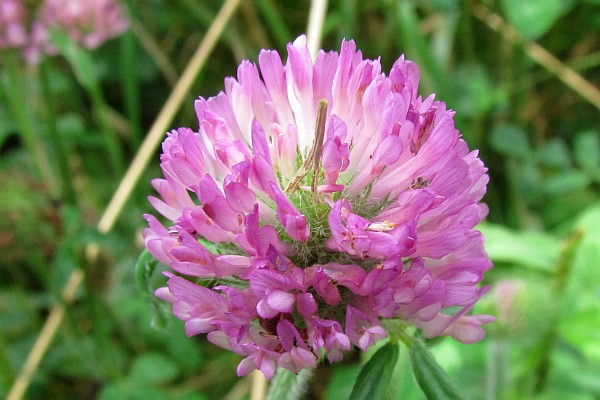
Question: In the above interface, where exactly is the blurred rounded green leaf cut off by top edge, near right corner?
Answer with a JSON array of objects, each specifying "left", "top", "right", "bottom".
[{"left": 500, "top": 0, "right": 574, "bottom": 39}]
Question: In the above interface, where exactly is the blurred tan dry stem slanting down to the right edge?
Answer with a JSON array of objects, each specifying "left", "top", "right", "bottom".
[{"left": 473, "top": 4, "right": 600, "bottom": 110}]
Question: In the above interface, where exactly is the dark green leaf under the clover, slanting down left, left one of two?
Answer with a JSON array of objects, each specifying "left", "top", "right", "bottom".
[{"left": 350, "top": 342, "right": 400, "bottom": 400}]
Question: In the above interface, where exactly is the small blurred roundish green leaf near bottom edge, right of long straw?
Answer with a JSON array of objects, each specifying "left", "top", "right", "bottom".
[{"left": 129, "top": 353, "right": 179, "bottom": 386}]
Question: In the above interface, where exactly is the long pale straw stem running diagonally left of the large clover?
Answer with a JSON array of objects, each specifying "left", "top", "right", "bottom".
[{"left": 7, "top": 0, "right": 241, "bottom": 400}]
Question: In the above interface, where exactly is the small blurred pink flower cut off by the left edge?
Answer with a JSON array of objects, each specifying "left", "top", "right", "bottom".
[{"left": 0, "top": 0, "right": 28, "bottom": 50}]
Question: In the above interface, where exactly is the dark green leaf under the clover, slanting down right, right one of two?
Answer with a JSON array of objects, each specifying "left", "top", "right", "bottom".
[{"left": 410, "top": 339, "right": 463, "bottom": 400}]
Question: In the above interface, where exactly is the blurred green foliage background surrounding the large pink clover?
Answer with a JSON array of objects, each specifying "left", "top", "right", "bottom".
[{"left": 0, "top": 0, "right": 600, "bottom": 400}]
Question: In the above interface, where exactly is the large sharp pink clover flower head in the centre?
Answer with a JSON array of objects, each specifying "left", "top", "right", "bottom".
[{"left": 144, "top": 36, "right": 492, "bottom": 378}]
